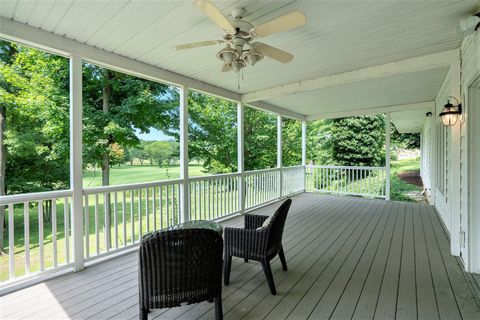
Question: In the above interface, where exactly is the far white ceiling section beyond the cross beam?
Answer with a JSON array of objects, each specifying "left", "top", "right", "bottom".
[{"left": 266, "top": 67, "right": 448, "bottom": 119}]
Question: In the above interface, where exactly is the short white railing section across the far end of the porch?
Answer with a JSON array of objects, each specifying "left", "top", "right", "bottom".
[{"left": 305, "top": 166, "right": 387, "bottom": 198}]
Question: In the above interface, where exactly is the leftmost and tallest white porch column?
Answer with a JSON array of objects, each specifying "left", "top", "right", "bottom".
[{"left": 70, "top": 55, "right": 84, "bottom": 272}]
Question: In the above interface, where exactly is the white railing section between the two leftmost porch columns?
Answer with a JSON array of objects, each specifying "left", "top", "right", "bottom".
[{"left": 83, "top": 179, "right": 182, "bottom": 261}]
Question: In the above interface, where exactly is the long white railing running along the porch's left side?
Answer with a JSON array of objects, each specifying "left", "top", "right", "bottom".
[{"left": 0, "top": 166, "right": 304, "bottom": 283}]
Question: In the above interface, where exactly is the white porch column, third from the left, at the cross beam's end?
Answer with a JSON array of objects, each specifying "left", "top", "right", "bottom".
[{"left": 237, "top": 102, "right": 245, "bottom": 214}]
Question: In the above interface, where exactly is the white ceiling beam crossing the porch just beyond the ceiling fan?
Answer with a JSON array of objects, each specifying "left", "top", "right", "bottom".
[{"left": 241, "top": 49, "right": 459, "bottom": 103}]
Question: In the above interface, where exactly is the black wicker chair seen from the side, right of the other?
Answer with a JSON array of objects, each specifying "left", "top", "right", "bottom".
[{"left": 224, "top": 199, "right": 292, "bottom": 295}]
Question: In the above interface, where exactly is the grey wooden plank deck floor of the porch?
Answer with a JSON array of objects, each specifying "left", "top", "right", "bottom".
[{"left": 0, "top": 193, "right": 480, "bottom": 320}]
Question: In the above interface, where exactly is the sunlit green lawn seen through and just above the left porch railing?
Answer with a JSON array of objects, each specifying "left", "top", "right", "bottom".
[{"left": 0, "top": 165, "right": 208, "bottom": 281}]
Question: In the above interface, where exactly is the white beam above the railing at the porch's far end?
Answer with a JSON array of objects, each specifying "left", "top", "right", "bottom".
[{"left": 306, "top": 101, "right": 435, "bottom": 121}]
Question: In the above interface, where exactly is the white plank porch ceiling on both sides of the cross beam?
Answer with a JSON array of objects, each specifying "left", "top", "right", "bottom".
[{"left": 0, "top": 0, "right": 478, "bottom": 119}]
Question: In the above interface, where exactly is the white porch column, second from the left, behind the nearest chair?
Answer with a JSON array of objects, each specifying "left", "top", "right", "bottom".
[{"left": 179, "top": 86, "right": 190, "bottom": 222}]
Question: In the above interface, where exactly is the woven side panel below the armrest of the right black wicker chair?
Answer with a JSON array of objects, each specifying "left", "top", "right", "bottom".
[{"left": 224, "top": 228, "right": 268, "bottom": 259}]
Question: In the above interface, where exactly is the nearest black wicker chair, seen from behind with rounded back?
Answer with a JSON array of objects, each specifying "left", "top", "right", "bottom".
[{"left": 139, "top": 229, "right": 223, "bottom": 320}]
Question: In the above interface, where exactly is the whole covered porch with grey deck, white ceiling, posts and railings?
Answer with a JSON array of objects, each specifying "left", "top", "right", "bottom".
[{"left": 0, "top": 0, "right": 480, "bottom": 319}]
